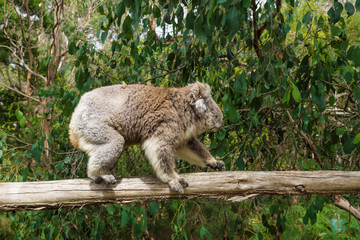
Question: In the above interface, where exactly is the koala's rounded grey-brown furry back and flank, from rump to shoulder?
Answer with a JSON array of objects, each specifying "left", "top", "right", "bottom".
[{"left": 69, "top": 85, "right": 176, "bottom": 151}]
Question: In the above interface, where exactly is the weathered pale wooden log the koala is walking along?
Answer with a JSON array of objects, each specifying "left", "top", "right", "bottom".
[{"left": 0, "top": 171, "right": 360, "bottom": 211}]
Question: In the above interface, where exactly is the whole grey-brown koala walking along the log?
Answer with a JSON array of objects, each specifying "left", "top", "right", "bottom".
[{"left": 69, "top": 82, "right": 224, "bottom": 194}]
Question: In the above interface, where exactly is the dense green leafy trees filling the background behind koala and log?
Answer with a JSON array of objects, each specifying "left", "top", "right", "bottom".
[{"left": 0, "top": 0, "right": 360, "bottom": 239}]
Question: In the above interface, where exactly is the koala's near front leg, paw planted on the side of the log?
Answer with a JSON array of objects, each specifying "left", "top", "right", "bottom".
[{"left": 142, "top": 138, "right": 189, "bottom": 194}]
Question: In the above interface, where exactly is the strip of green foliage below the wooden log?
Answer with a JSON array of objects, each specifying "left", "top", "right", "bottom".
[{"left": 0, "top": 197, "right": 358, "bottom": 239}]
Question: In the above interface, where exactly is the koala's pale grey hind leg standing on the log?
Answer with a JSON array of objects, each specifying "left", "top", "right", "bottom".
[{"left": 80, "top": 123, "right": 125, "bottom": 184}]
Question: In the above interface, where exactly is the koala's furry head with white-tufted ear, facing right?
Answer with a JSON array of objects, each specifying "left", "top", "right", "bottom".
[{"left": 189, "top": 82, "right": 224, "bottom": 131}]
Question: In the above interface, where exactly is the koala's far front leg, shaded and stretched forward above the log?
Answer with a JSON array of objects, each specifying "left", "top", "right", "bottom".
[{"left": 175, "top": 137, "right": 225, "bottom": 170}]
